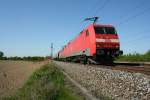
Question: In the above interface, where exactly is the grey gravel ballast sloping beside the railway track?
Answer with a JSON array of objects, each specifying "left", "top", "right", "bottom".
[{"left": 55, "top": 61, "right": 150, "bottom": 100}]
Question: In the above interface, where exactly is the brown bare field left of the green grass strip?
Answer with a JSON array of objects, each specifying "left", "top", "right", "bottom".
[{"left": 0, "top": 60, "right": 47, "bottom": 97}]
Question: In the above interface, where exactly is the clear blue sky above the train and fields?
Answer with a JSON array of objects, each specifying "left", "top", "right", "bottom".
[{"left": 0, "top": 0, "right": 150, "bottom": 56}]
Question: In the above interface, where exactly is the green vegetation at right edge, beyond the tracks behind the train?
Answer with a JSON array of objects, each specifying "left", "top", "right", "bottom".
[{"left": 116, "top": 50, "right": 150, "bottom": 62}]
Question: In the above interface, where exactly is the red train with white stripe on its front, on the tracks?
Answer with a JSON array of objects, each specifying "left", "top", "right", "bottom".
[{"left": 57, "top": 23, "right": 123, "bottom": 63}]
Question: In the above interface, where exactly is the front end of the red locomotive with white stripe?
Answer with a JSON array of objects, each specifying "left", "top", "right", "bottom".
[{"left": 94, "top": 25, "right": 122, "bottom": 61}]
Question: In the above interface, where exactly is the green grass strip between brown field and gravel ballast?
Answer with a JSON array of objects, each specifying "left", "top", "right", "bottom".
[{"left": 4, "top": 63, "right": 81, "bottom": 100}]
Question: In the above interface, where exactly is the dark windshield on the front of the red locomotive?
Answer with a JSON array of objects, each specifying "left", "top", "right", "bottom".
[{"left": 94, "top": 27, "right": 116, "bottom": 34}]
